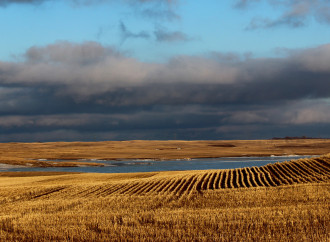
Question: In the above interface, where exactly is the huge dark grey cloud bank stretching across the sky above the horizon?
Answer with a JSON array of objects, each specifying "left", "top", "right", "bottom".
[{"left": 0, "top": 42, "right": 330, "bottom": 141}]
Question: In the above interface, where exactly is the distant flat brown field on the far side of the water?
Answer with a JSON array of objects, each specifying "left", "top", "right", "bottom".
[{"left": 0, "top": 139, "right": 330, "bottom": 167}]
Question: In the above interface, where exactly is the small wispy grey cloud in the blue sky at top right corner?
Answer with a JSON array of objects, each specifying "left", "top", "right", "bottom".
[{"left": 235, "top": 0, "right": 330, "bottom": 30}]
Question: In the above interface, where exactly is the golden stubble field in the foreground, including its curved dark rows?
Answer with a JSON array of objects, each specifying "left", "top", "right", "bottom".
[{"left": 0, "top": 154, "right": 330, "bottom": 241}]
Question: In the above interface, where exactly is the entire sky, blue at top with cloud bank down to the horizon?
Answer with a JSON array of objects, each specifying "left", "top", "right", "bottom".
[{"left": 0, "top": 0, "right": 330, "bottom": 142}]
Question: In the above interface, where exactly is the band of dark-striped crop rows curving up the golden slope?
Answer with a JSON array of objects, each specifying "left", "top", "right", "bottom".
[{"left": 23, "top": 157, "right": 330, "bottom": 198}]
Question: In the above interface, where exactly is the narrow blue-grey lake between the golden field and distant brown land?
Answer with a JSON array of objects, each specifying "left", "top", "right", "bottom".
[{"left": 0, "top": 156, "right": 311, "bottom": 173}]
